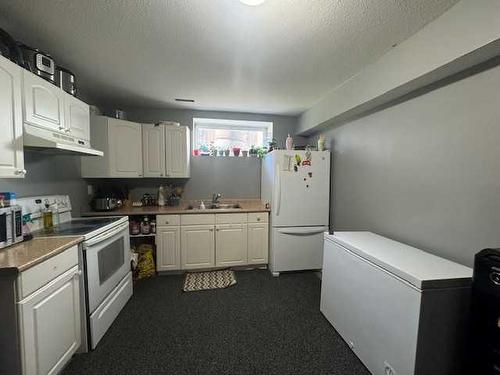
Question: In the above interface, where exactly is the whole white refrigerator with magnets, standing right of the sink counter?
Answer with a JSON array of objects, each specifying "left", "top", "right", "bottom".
[{"left": 261, "top": 150, "right": 330, "bottom": 276}]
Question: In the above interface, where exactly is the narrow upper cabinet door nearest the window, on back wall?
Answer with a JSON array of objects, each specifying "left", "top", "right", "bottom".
[{"left": 165, "top": 125, "right": 189, "bottom": 177}]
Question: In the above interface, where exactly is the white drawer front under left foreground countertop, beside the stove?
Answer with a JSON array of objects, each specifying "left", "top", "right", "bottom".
[{"left": 18, "top": 245, "right": 78, "bottom": 299}]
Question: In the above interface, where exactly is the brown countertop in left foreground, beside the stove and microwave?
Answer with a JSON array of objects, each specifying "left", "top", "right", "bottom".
[{"left": 0, "top": 236, "right": 83, "bottom": 273}]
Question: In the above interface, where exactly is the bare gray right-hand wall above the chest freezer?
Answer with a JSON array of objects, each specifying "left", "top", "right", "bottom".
[{"left": 311, "top": 63, "right": 500, "bottom": 265}]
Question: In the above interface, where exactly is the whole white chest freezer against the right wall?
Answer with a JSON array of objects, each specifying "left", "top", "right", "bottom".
[{"left": 321, "top": 232, "right": 472, "bottom": 375}]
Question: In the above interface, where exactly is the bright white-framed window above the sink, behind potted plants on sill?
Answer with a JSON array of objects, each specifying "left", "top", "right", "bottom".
[{"left": 193, "top": 118, "right": 273, "bottom": 152}]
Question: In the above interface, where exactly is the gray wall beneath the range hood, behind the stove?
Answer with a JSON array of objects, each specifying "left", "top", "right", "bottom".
[{"left": 0, "top": 151, "right": 87, "bottom": 216}]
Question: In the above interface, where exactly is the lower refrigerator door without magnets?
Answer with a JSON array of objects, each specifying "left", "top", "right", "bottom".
[{"left": 270, "top": 226, "right": 328, "bottom": 272}]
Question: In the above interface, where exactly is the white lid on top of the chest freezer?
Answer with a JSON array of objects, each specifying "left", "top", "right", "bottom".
[{"left": 325, "top": 232, "right": 472, "bottom": 290}]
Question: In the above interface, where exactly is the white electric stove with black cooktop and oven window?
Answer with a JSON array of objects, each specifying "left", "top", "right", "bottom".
[{"left": 18, "top": 195, "right": 133, "bottom": 352}]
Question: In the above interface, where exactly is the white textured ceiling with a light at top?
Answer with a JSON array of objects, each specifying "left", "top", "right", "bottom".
[{"left": 0, "top": 0, "right": 456, "bottom": 115}]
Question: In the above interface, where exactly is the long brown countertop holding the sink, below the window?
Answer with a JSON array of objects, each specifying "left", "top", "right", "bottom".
[{"left": 82, "top": 199, "right": 270, "bottom": 216}]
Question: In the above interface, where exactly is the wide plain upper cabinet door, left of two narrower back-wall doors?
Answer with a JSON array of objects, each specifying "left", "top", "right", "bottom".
[{"left": 108, "top": 118, "right": 142, "bottom": 177}]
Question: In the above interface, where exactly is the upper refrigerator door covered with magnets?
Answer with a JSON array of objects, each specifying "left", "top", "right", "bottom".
[{"left": 271, "top": 150, "right": 330, "bottom": 227}]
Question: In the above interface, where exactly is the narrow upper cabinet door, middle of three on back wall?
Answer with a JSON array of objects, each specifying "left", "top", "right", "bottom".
[{"left": 142, "top": 124, "right": 165, "bottom": 177}]
